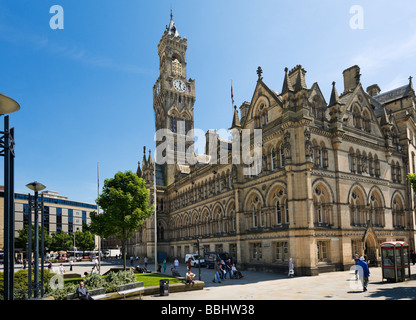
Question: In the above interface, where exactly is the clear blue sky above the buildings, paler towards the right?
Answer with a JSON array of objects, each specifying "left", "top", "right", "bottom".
[{"left": 0, "top": 0, "right": 416, "bottom": 203}]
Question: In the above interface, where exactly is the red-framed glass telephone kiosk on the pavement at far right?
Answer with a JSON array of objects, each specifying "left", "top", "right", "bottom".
[{"left": 380, "top": 241, "right": 410, "bottom": 282}]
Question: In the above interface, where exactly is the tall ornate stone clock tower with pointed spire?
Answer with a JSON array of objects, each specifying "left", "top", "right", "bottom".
[{"left": 153, "top": 13, "right": 195, "bottom": 185}]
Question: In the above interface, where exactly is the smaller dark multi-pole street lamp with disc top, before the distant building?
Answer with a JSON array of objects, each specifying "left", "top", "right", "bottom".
[{"left": 26, "top": 181, "right": 46, "bottom": 299}]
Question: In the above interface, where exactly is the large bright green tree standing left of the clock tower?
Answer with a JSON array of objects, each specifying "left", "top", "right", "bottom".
[{"left": 90, "top": 171, "right": 153, "bottom": 269}]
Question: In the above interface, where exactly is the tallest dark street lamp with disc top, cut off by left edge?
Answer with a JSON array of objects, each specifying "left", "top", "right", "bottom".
[{"left": 0, "top": 93, "right": 20, "bottom": 300}]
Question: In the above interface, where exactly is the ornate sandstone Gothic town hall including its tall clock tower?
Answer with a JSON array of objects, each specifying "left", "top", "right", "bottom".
[{"left": 128, "top": 14, "right": 416, "bottom": 275}]
